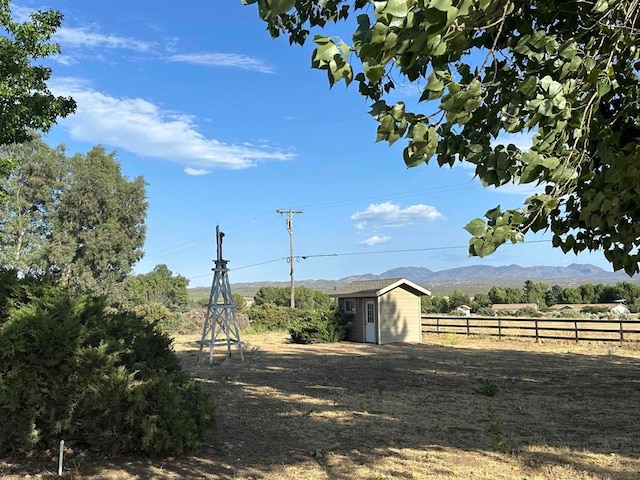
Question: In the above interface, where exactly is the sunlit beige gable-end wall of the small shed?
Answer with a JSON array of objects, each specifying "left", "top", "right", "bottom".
[{"left": 379, "top": 288, "right": 422, "bottom": 343}]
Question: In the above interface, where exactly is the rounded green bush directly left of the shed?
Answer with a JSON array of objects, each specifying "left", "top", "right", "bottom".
[{"left": 289, "top": 310, "right": 350, "bottom": 344}]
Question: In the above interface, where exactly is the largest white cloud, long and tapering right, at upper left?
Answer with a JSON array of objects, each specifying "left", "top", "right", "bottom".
[{"left": 51, "top": 78, "right": 294, "bottom": 175}]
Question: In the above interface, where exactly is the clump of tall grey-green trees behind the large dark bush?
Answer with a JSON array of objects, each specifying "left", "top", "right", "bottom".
[{"left": 0, "top": 138, "right": 147, "bottom": 294}]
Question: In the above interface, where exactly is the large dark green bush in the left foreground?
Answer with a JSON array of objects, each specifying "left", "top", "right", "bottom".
[{"left": 0, "top": 293, "right": 214, "bottom": 455}]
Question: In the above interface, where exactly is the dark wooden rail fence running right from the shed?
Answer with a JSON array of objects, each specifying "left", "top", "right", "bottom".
[{"left": 422, "top": 315, "right": 640, "bottom": 343}]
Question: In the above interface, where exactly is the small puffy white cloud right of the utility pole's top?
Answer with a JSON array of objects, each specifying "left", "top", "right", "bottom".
[{"left": 351, "top": 202, "right": 443, "bottom": 230}]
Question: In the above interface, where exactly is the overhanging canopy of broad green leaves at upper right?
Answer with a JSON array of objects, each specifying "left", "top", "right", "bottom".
[{"left": 243, "top": 0, "right": 640, "bottom": 274}]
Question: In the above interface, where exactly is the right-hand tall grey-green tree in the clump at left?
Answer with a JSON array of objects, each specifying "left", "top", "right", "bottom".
[{"left": 46, "top": 146, "right": 147, "bottom": 294}]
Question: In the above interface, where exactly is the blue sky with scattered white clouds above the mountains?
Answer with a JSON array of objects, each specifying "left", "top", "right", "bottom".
[{"left": 13, "top": 0, "right": 611, "bottom": 286}]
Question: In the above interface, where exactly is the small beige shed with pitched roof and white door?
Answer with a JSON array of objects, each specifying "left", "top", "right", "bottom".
[{"left": 331, "top": 278, "right": 431, "bottom": 344}]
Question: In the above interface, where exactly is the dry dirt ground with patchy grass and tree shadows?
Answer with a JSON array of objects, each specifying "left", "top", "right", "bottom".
[{"left": 0, "top": 334, "right": 640, "bottom": 480}]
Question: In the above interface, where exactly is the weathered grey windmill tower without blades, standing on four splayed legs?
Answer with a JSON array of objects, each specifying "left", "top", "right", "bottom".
[{"left": 200, "top": 225, "right": 244, "bottom": 364}]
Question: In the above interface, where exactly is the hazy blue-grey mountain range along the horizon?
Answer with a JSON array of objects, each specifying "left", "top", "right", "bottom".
[{"left": 190, "top": 263, "right": 640, "bottom": 296}]
